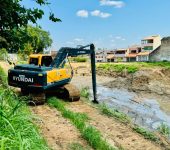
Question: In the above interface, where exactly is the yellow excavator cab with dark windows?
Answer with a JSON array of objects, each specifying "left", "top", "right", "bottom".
[{"left": 28, "top": 54, "right": 53, "bottom": 67}]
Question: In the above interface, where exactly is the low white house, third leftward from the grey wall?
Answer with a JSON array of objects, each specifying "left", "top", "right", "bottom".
[{"left": 114, "top": 49, "right": 127, "bottom": 62}]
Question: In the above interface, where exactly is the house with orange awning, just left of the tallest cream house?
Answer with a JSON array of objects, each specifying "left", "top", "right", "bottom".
[{"left": 126, "top": 45, "right": 141, "bottom": 62}]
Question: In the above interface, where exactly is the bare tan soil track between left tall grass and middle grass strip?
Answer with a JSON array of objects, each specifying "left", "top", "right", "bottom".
[{"left": 30, "top": 105, "right": 88, "bottom": 150}]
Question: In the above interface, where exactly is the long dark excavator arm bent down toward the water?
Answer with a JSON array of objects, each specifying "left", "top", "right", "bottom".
[{"left": 51, "top": 44, "right": 98, "bottom": 103}]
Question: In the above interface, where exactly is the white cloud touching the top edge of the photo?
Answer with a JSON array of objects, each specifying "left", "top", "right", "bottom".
[{"left": 100, "top": 0, "right": 125, "bottom": 8}]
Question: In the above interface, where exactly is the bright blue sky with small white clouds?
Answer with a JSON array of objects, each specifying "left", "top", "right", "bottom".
[{"left": 22, "top": 0, "right": 170, "bottom": 50}]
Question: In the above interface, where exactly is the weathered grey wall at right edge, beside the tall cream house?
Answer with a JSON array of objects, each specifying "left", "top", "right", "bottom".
[{"left": 149, "top": 37, "right": 170, "bottom": 61}]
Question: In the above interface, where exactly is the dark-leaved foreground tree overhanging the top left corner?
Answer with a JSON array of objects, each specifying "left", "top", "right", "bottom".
[{"left": 0, "top": 0, "right": 61, "bottom": 52}]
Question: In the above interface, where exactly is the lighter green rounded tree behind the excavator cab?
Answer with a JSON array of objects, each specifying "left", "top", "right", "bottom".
[{"left": 16, "top": 25, "right": 52, "bottom": 55}]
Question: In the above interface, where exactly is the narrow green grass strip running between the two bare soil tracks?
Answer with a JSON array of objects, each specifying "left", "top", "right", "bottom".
[{"left": 48, "top": 97, "right": 115, "bottom": 150}]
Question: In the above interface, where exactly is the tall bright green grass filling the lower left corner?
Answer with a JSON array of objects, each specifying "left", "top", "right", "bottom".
[{"left": 0, "top": 68, "right": 49, "bottom": 150}]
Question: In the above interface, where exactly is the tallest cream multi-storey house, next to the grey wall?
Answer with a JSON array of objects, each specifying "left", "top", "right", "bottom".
[{"left": 136, "top": 35, "right": 161, "bottom": 61}]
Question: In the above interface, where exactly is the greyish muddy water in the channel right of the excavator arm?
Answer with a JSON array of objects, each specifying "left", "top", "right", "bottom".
[{"left": 89, "top": 86, "right": 170, "bottom": 130}]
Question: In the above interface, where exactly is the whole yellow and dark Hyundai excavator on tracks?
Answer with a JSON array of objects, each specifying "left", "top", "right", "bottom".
[{"left": 8, "top": 44, "right": 98, "bottom": 104}]
